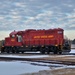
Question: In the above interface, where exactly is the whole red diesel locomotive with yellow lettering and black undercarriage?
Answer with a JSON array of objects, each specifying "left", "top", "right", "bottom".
[{"left": 1, "top": 28, "right": 70, "bottom": 54}]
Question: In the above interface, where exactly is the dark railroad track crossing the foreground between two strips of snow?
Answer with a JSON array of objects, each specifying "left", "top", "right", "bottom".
[{"left": 0, "top": 57, "right": 75, "bottom": 65}]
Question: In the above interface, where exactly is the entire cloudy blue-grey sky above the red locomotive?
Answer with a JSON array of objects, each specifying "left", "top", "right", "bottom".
[{"left": 0, "top": 0, "right": 75, "bottom": 39}]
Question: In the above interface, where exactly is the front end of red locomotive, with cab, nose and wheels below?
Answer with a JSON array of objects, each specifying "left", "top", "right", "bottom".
[{"left": 1, "top": 31, "right": 22, "bottom": 53}]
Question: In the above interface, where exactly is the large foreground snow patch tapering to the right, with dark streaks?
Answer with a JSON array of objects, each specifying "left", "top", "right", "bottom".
[{"left": 0, "top": 61, "right": 65, "bottom": 75}]
